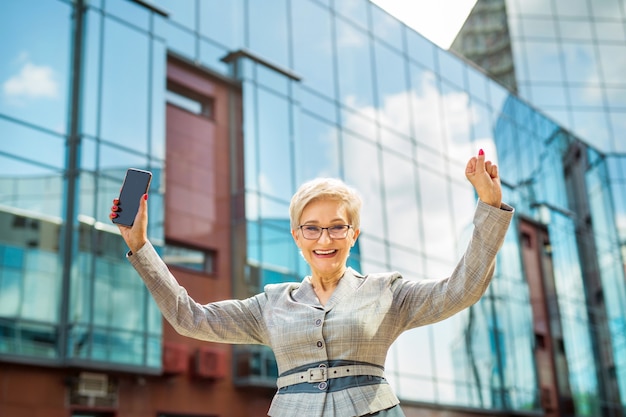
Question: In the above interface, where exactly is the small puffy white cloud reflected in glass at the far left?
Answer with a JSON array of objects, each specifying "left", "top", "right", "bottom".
[{"left": 2, "top": 62, "right": 59, "bottom": 98}]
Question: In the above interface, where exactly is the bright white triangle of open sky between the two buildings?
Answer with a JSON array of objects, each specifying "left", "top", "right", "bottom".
[{"left": 371, "top": 0, "right": 476, "bottom": 49}]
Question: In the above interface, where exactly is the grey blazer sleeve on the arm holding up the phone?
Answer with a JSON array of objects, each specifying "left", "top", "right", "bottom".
[{"left": 127, "top": 242, "right": 267, "bottom": 344}]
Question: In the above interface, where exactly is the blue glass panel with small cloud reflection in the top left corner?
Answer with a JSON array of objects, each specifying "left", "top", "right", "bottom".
[{"left": 0, "top": 0, "right": 72, "bottom": 133}]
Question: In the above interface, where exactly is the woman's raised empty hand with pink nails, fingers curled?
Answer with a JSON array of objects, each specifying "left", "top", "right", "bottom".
[{"left": 465, "top": 149, "right": 502, "bottom": 208}]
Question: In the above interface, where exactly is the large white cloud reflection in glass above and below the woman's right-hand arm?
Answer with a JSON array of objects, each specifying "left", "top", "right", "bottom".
[{"left": 332, "top": 73, "right": 497, "bottom": 401}]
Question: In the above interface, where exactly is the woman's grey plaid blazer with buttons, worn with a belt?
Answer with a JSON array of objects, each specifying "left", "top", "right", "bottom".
[{"left": 128, "top": 201, "right": 513, "bottom": 417}]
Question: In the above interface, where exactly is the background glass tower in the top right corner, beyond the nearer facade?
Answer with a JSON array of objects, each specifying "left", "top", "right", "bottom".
[{"left": 451, "top": 0, "right": 626, "bottom": 153}]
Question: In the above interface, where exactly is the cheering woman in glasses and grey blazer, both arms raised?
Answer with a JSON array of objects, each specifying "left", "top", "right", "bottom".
[{"left": 111, "top": 150, "right": 513, "bottom": 417}]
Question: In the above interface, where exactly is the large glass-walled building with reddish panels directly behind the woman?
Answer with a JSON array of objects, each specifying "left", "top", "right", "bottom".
[{"left": 0, "top": 0, "right": 626, "bottom": 417}]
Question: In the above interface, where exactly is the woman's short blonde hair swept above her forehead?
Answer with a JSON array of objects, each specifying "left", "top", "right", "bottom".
[{"left": 289, "top": 178, "right": 362, "bottom": 230}]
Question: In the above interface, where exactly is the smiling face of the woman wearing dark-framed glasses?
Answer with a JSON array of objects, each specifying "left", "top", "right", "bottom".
[{"left": 291, "top": 200, "right": 359, "bottom": 278}]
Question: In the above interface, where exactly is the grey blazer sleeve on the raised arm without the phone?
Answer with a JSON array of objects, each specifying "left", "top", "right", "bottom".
[{"left": 391, "top": 200, "right": 514, "bottom": 331}]
